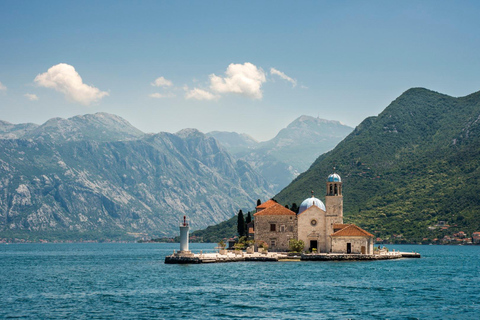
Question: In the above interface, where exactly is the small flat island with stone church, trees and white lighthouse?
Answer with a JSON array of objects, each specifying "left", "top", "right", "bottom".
[{"left": 165, "top": 172, "right": 420, "bottom": 263}]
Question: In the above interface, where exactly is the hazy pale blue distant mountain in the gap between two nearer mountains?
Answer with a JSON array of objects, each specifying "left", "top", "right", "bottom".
[{"left": 207, "top": 116, "right": 353, "bottom": 192}]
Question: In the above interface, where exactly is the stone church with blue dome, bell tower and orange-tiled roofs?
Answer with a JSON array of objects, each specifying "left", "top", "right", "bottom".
[{"left": 254, "top": 173, "right": 374, "bottom": 254}]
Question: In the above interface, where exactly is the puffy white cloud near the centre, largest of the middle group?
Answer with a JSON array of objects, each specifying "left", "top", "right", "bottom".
[{"left": 210, "top": 62, "right": 267, "bottom": 99}]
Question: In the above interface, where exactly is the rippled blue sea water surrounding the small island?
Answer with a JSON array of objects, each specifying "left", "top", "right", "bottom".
[{"left": 0, "top": 243, "right": 480, "bottom": 319}]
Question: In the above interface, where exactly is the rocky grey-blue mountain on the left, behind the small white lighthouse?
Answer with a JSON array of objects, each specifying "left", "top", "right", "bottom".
[{"left": 0, "top": 113, "right": 272, "bottom": 240}]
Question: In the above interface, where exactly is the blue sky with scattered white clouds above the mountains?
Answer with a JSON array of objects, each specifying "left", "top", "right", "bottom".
[{"left": 0, "top": 0, "right": 480, "bottom": 141}]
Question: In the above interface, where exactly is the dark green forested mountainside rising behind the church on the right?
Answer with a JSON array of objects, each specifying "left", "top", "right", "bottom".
[{"left": 275, "top": 88, "right": 480, "bottom": 241}]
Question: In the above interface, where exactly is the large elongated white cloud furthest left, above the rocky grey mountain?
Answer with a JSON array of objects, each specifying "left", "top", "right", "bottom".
[{"left": 34, "top": 63, "right": 108, "bottom": 106}]
